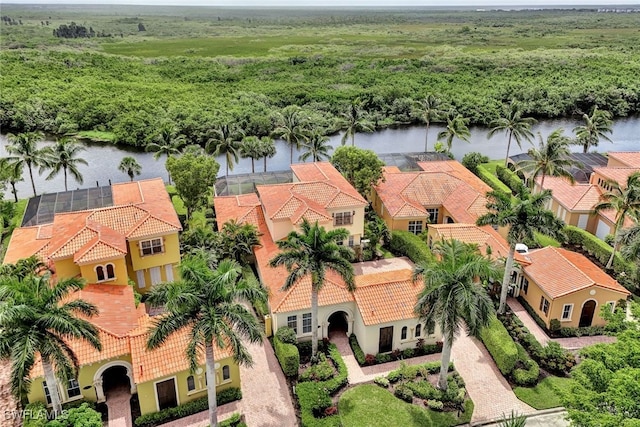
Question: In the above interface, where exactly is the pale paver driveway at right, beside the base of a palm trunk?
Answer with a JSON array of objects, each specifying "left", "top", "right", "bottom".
[{"left": 452, "top": 331, "right": 535, "bottom": 424}]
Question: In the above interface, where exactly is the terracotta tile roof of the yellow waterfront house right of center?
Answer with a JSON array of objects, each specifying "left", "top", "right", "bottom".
[{"left": 375, "top": 161, "right": 491, "bottom": 222}]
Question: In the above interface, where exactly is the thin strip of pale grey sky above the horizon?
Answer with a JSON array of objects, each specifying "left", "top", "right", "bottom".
[{"left": 5, "top": 0, "right": 640, "bottom": 7}]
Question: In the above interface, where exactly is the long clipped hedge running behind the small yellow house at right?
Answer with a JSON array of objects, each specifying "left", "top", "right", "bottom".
[{"left": 564, "top": 225, "right": 636, "bottom": 292}]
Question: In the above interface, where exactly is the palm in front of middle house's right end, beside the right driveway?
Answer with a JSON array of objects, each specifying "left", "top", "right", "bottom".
[{"left": 414, "top": 240, "right": 501, "bottom": 390}]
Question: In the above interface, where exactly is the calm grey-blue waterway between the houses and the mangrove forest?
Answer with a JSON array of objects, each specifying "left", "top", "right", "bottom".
[{"left": 0, "top": 116, "right": 640, "bottom": 197}]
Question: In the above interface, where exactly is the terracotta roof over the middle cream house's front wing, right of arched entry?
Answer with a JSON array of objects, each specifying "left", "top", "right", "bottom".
[{"left": 354, "top": 270, "right": 423, "bottom": 326}]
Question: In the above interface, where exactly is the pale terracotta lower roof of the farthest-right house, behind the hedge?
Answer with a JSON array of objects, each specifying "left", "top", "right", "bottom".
[{"left": 536, "top": 176, "right": 602, "bottom": 211}]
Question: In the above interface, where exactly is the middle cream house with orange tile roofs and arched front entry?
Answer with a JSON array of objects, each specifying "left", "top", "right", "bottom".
[{"left": 214, "top": 162, "right": 441, "bottom": 354}]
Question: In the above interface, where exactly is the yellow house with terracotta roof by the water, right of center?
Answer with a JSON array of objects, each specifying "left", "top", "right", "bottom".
[{"left": 371, "top": 160, "right": 492, "bottom": 234}]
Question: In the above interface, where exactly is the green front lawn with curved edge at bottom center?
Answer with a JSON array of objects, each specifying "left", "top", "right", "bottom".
[{"left": 338, "top": 384, "right": 473, "bottom": 427}]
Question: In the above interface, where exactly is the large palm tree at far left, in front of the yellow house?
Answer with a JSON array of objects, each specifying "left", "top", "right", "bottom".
[{"left": 0, "top": 270, "right": 102, "bottom": 413}]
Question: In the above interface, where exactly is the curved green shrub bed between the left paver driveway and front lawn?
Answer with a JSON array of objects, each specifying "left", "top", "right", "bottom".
[{"left": 295, "top": 344, "right": 348, "bottom": 427}]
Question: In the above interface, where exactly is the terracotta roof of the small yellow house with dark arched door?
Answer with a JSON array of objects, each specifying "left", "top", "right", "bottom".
[{"left": 524, "top": 246, "right": 630, "bottom": 298}]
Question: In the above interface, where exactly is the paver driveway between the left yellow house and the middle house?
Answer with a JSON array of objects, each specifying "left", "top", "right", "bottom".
[{"left": 158, "top": 340, "right": 298, "bottom": 427}]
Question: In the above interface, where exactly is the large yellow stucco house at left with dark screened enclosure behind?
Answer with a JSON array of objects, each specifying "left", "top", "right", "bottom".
[{"left": 4, "top": 178, "right": 240, "bottom": 414}]
